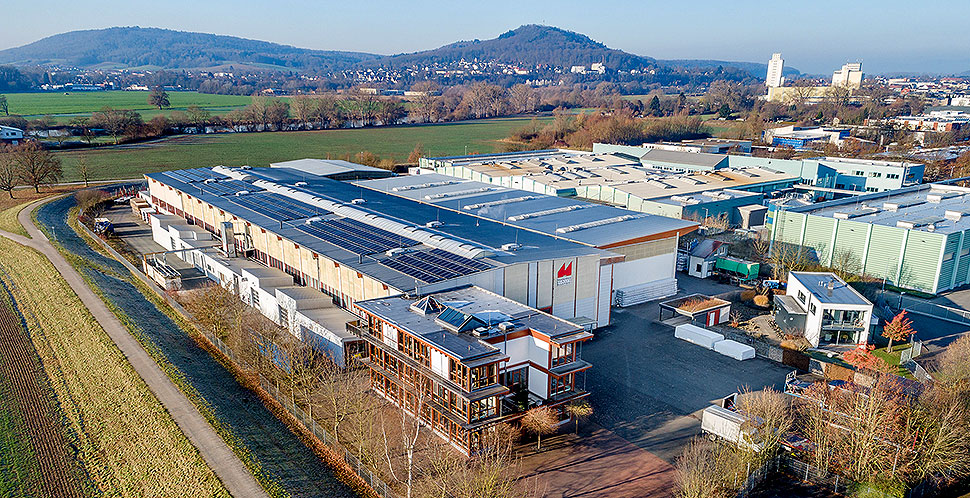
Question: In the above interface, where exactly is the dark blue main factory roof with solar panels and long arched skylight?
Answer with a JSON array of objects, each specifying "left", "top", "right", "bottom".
[{"left": 146, "top": 167, "right": 612, "bottom": 290}]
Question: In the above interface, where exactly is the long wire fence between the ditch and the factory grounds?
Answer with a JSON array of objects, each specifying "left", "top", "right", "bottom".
[{"left": 80, "top": 220, "right": 396, "bottom": 498}]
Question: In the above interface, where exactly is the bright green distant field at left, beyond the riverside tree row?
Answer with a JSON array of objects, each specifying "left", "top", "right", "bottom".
[{"left": 6, "top": 91, "right": 252, "bottom": 122}]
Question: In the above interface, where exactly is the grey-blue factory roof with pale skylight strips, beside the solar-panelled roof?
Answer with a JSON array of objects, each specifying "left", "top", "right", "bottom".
[{"left": 356, "top": 173, "right": 697, "bottom": 248}]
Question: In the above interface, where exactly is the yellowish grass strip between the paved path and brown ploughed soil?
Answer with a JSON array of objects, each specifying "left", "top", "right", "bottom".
[{"left": 0, "top": 235, "right": 228, "bottom": 497}]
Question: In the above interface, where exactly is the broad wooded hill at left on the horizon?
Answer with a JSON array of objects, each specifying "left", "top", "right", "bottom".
[{"left": 0, "top": 27, "right": 379, "bottom": 71}]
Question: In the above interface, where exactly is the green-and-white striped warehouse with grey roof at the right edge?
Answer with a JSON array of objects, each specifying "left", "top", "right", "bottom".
[{"left": 771, "top": 184, "right": 970, "bottom": 293}]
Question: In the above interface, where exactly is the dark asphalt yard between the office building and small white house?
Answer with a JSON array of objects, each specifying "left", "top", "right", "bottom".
[{"left": 582, "top": 290, "right": 791, "bottom": 462}]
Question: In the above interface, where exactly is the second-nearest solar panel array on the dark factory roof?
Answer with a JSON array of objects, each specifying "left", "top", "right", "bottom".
[{"left": 294, "top": 218, "right": 418, "bottom": 254}]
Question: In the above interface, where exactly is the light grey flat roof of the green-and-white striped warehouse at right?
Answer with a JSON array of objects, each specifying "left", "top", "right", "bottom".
[{"left": 787, "top": 183, "right": 970, "bottom": 234}]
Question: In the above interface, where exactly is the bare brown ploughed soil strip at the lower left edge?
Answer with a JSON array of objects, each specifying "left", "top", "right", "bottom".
[{"left": 0, "top": 291, "right": 84, "bottom": 498}]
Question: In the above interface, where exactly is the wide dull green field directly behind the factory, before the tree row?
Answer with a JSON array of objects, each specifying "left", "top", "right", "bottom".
[{"left": 57, "top": 118, "right": 551, "bottom": 182}]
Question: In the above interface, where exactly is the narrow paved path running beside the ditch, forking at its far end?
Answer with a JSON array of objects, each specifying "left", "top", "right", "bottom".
[{"left": 0, "top": 200, "right": 269, "bottom": 498}]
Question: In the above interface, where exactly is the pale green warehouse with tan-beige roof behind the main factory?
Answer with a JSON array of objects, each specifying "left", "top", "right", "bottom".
[{"left": 419, "top": 149, "right": 799, "bottom": 225}]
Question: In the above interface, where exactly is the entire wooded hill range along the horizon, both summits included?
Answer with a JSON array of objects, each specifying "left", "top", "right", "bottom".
[{"left": 0, "top": 24, "right": 797, "bottom": 78}]
